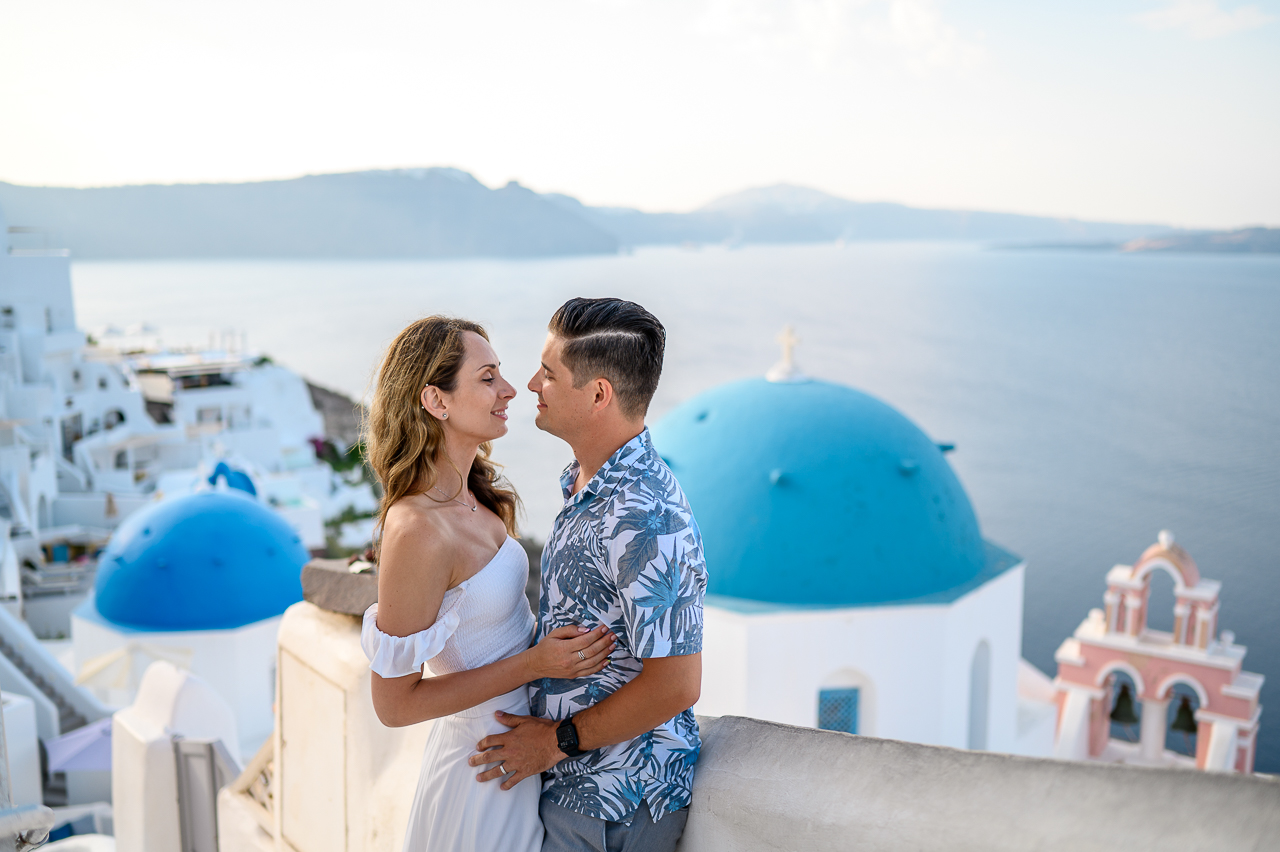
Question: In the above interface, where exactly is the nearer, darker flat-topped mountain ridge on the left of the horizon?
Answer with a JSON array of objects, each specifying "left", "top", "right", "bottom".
[{"left": 0, "top": 169, "right": 618, "bottom": 258}]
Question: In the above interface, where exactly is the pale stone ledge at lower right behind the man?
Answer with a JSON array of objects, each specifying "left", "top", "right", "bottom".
[{"left": 678, "top": 716, "right": 1280, "bottom": 852}]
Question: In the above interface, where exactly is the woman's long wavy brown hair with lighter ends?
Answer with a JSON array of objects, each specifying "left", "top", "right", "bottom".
[{"left": 365, "top": 316, "right": 520, "bottom": 542}]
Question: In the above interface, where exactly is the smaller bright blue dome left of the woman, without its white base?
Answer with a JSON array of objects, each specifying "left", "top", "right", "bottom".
[{"left": 95, "top": 491, "right": 308, "bottom": 631}]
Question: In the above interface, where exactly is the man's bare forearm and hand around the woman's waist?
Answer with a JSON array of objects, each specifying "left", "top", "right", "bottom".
[{"left": 468, "top": 654, "right": 703, "bottom": 789}]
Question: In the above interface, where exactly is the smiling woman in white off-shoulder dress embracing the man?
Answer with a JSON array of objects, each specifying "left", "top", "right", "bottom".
[{"left": 361, "top": 316, "right": 614, "bottom": 852}]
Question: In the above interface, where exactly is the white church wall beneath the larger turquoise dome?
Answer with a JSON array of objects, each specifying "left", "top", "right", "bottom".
[{"left": 696, "top": 565, "right": 1024, "bottom": 751}]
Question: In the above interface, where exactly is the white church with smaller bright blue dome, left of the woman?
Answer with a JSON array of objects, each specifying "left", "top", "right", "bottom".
[{"left": 72, "top": 487, "right": 308, "bottom": 753}]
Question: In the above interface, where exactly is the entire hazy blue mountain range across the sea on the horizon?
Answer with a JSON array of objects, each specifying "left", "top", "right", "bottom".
[{"left": 0, "top": 168, "right": 1172, "bottom": 258}]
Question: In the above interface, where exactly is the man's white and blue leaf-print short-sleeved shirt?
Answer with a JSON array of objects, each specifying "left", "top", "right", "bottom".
[{"left": 531, "top": 429, "right": 707, "bottom": 823}]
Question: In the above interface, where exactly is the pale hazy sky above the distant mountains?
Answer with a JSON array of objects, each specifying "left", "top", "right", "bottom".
[{"left": 0, "top": 0, "right": 1280, "bottom": 226}]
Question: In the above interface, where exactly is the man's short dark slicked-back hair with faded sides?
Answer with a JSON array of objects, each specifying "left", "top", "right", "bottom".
[{"left": 547, "top": 298, "right": 667, "bottom": 417}]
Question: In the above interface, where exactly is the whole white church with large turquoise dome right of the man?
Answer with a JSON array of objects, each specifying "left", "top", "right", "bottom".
[{"left": 653, "top": 347, "right": 1056, "bottom": 755}]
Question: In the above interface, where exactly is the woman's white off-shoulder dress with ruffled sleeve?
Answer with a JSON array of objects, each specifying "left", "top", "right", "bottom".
[{"left": 360, "top": 536, "right": 543, "bottom": 852}]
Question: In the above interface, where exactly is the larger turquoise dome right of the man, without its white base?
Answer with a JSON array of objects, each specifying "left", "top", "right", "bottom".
[{"left": 653, "top": 379, "right": 988, "bottom": 606}]
